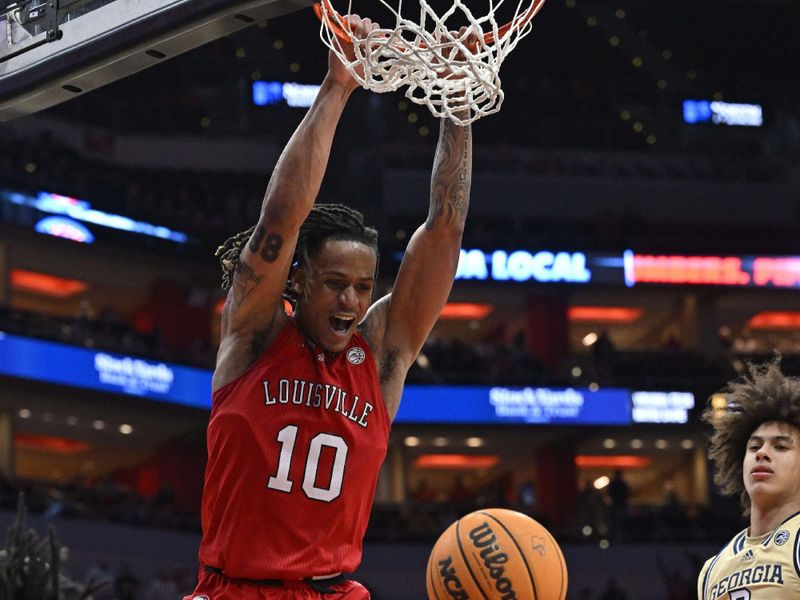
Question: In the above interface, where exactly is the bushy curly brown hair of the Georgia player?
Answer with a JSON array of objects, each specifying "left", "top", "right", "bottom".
[{"left": 703, "top": 356, "right": 800, "bottom": 516}]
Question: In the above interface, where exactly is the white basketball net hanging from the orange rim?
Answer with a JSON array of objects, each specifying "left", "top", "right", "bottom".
[{"left": 314, "top": 0, "right": 544, "bottom": 125}]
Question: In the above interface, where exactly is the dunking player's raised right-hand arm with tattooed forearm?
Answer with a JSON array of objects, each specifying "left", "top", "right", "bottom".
[{"left": 364, "top": 119, "right": 472, "bottom": 417}]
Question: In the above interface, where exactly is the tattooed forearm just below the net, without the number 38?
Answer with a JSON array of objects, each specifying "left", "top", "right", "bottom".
[{"left": 425, "top": 119, "right": 472, "bottom": 229}]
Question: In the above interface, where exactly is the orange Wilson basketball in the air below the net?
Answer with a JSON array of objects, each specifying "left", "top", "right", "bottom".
[{"left": 426, "top": 508, "right": 567, "bottom": 600}]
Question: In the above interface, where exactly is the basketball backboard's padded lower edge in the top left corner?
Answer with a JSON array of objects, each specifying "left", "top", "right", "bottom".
[{"left": 0, "top": 0, "right": 313, "bottom": 121}]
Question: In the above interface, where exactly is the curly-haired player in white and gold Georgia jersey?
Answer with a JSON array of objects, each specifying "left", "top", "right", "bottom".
[{"left": 697, "top": 361, "right": 800, "bottom": 600}]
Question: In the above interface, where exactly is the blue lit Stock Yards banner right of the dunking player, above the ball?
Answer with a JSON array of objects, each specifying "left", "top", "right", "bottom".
[{"left": 395, "top": 385, "right": 631, "bottom": 425}]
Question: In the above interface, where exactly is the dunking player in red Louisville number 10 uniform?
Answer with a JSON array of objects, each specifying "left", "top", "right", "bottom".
[{"left": 186, "top": 16, "right": 472, "bottom": 600}]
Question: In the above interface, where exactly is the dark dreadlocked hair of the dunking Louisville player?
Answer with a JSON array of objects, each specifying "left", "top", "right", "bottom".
[{"left": 215, "top": 204, "right": 380, "bottom": 305}]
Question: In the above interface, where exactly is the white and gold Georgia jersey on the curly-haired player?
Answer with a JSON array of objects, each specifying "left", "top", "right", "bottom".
[{"left": 697, "top": 513, "right": 800, "bottom": 600}]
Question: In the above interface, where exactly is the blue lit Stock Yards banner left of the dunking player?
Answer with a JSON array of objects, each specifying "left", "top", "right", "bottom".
[{"left": 0, "top": 332, "right": 211, "bottom": 409}]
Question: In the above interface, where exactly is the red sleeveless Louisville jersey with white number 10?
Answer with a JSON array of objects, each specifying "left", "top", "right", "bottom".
[{"left": 200, "top": 319, "right": 390, "bottom": 579}]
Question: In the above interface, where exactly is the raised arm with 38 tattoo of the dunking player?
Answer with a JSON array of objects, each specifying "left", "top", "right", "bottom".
[{"left": 214, "top": 16, "right": 374, "bottom": 389}]
